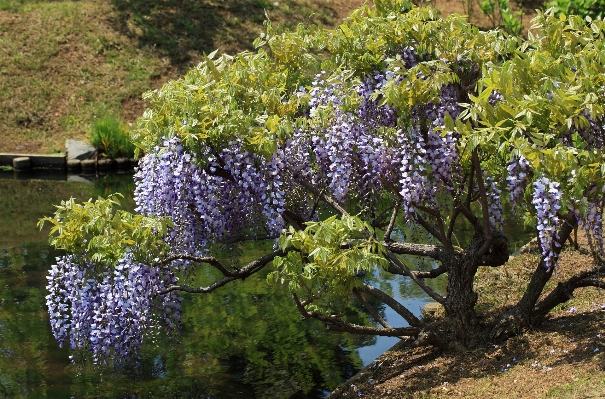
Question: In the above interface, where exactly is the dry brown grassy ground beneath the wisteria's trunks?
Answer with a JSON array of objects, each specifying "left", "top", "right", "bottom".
[{"left": 330, "top": 233, "right": 605, "bottom": 399}]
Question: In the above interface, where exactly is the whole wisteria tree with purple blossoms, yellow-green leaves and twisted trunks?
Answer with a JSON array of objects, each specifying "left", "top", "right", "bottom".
[{"left": 42, "top": 0, "right": 605, "bottom": 361}]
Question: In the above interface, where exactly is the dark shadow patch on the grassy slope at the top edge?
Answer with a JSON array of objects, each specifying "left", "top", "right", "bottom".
[{"left": 111, "top": 0, "right": 336, "bottom": 69}]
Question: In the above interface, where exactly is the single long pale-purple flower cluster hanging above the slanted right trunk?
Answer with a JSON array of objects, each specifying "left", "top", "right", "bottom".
[{"left": 532, "top": 176, "right": 563, "bottom": 270}]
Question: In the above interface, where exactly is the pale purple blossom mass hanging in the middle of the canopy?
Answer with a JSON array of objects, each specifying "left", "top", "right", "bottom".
[{"left": 307, "top": 72, "right": 397, "bottom": 205}]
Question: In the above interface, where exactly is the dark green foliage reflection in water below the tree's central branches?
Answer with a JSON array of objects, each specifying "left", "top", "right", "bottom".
[{"left": 177, "top": 266, "right": 365, "bottom": 398}]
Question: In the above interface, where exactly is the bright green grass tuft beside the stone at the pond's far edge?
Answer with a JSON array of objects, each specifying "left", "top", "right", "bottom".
[{"left": 90, "top": 114, "right": 135, "bottom": 158}]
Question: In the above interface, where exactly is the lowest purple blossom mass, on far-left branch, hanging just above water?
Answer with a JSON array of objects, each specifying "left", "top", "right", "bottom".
[{"left": 46, "top": 254, "right": 181, "bottom": 363}]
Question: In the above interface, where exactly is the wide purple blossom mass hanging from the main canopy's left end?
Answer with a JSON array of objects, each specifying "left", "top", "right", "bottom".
[{"left": 135, "top": 137, "right": 285, "bottom": 250}]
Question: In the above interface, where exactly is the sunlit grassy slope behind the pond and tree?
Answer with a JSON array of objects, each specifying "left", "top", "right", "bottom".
[{"left": 0, "top": 0, "right": 363, "bottom": 153}]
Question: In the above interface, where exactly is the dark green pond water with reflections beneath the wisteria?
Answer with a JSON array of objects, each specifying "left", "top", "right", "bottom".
[{"left": 0, "top": 172, "right": 532, "bottom": 398}]
